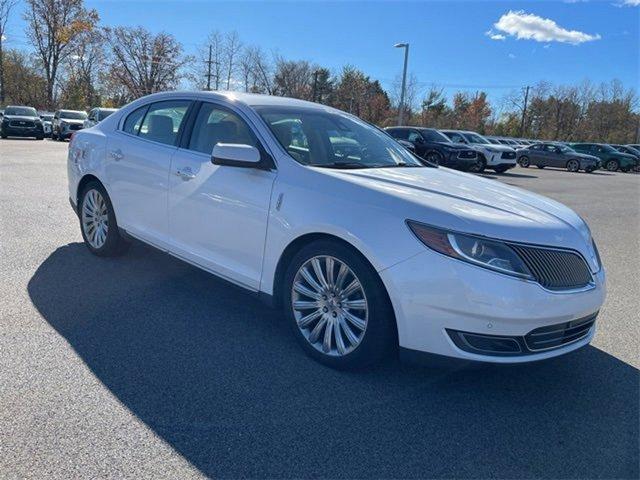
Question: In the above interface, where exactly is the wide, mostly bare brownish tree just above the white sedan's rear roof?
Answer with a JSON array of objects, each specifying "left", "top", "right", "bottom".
[{"left": 105, "top": 27, "right": 191, "bottom": 100}]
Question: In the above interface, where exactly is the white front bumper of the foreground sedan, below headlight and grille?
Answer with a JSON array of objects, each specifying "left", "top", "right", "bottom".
[{"left": 380, "top": 250, "right": 605, "bottom": 363}]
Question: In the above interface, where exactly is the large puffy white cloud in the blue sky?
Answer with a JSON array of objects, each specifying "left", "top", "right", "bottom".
[{"left": 490, "top": 10, "right": 600, "bottom": 45}]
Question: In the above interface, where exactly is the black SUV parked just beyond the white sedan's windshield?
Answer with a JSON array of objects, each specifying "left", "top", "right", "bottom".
[{"left": 385, "top": 127, "right": 481, "bottom": 172}]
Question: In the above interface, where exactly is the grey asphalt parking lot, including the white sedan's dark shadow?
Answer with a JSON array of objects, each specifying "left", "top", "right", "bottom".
[{"left": 0, "top": 140, "right": 640, "bottom": 479}]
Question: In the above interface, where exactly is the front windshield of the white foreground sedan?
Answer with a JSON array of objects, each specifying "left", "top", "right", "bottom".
[{"left": 255, "top": 106, "right": 423, "bottom": 168}]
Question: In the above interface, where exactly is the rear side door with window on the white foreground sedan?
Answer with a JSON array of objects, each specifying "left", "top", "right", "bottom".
[{"left": 105, "top": 100, "right": 192, "bottom": 249}]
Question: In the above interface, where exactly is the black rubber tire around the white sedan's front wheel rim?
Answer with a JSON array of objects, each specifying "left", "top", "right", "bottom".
[{"left": 282, "top": 240, "right": 398, "bottom": 370}]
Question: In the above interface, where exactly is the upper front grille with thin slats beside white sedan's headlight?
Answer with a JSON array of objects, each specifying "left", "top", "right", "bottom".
[{"left": 509, "top": 244, "right": 593, "bottom": 290}]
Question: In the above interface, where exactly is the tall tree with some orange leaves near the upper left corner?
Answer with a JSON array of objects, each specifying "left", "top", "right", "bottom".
[{"left": 24, "top": 0, "right": 98, "bottom": 108}]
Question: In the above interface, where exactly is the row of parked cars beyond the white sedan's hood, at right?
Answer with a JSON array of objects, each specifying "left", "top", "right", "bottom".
[{"left": 385, "top": 126, "right": 640, "bottom": 173}]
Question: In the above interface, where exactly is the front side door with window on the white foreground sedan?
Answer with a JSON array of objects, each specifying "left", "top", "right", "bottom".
[{"left": 168, "top": 102, "right": 276, "bottom": 290}]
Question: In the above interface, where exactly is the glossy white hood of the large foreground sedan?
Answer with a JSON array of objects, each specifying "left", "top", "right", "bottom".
[{"left": 317, "top": 168, "right": 598, "bottom": 270}]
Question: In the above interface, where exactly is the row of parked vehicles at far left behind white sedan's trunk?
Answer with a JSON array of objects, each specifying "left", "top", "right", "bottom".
[{"left": 0, "top": 105, "right": 117, "bottom": 141}]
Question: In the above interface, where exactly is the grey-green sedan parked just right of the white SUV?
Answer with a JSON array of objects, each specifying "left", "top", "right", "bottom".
[{"left": 517, "top": 143, "right": 600, "bottom": 173}]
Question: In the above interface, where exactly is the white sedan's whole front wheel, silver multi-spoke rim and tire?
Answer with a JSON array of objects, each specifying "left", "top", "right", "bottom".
[{"left": 283, "top": 240, "right": 398, "bottom": 370}]
